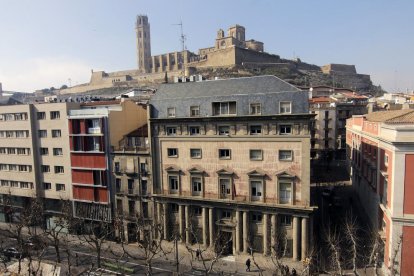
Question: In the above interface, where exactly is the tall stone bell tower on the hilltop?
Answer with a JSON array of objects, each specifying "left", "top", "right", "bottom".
[{"left": 135, "top": 15, "right": 151, "bottom": 73}]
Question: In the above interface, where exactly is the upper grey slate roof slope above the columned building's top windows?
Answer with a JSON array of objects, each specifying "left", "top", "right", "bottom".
[{"left": 151, "top": 76, "right": 301, "bottom": 101}]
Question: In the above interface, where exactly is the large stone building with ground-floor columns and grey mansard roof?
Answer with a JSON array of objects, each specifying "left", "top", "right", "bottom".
[{"left": 150, "top": 76, "right": 314, "bottom": 260}]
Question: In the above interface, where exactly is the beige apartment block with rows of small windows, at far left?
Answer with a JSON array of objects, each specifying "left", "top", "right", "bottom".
[{"left": 0, "top": 103, "right": 79, "bottom": 225}]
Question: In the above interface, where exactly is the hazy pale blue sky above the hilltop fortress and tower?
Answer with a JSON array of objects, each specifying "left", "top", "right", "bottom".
[{"left": 0, "top": 0, "right": 414, "bottom": 92}]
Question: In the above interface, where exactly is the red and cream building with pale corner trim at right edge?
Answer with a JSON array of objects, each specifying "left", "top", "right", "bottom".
[{"left": 346, "top": 109, "right": 414, "bottom": 275}]
